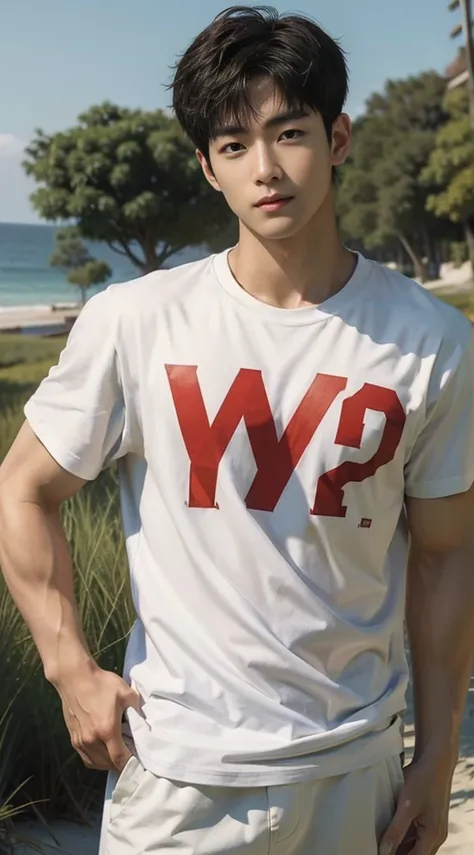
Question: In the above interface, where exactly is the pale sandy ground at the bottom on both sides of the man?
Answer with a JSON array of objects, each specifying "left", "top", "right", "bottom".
[{"left": 12, "top": 676, "right": 474, "bottom": 855}]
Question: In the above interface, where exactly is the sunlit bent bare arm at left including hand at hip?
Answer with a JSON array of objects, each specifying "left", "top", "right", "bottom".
[{"left": 0, "top": 423, "right": 139, "bottom": 770}]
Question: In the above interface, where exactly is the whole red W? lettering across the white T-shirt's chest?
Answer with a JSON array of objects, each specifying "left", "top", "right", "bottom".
[{"left": 165, "top": 365, "right": 405, "bottom": 516}]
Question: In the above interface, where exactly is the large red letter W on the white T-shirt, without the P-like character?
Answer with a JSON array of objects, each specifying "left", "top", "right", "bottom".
[{"left": 165, "top": 365, "right": 347, "bottom": 511}]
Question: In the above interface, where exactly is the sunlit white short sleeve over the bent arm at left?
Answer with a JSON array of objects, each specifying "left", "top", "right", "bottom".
[{"left": 24, "top": 289, "right": 131, "bottom": 480}]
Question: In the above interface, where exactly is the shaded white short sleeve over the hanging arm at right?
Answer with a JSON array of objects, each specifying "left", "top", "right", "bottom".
[{"left": 405, "top": 327, "right": 474, "bottom": 499}]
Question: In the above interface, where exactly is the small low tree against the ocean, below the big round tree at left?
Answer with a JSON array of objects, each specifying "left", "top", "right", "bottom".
[{"left": 50, "top": 228, "right": 112, "bottom": 306}]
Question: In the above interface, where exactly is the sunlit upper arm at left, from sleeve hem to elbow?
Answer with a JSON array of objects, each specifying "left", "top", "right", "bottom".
[{"left": 0, "top": 421, "right": 87, "bottom": 505}]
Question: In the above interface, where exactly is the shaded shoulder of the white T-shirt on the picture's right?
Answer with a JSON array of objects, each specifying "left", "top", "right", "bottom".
[{"left": 369, "top": 261, "right": 473, "bottom": 350}]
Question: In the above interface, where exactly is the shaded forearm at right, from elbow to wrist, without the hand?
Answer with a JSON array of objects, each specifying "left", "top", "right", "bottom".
[{"left": 406, "top": 548, "right": 474, "bottom": 765}]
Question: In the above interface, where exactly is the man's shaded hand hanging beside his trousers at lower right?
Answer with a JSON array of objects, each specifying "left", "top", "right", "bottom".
[{"left": 379, "top": 758, "right": 455, "bottom": 855}]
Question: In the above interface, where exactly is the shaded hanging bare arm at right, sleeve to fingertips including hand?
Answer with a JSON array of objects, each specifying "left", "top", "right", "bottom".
[{"left": 379, "top": 488, "right": 474, "bottom": 855}]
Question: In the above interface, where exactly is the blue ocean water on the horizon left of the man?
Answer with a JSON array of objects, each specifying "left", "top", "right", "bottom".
[{"left": 0, "top": 223, "right": 205, "bottom": 312}]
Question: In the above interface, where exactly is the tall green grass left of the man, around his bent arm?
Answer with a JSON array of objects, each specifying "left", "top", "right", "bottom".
[{"left": 0, "top": 335, "right": 133, "bottom": 824}]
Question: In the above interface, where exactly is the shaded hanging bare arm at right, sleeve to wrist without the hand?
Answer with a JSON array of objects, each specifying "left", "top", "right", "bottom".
[{"left": 406, "top": 489, "right": 474, "bottom": 768}]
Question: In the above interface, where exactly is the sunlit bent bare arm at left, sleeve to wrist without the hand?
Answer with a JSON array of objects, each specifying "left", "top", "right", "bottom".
[{"left": 0, "top": 423, "right": 91, "bottom": 682}]
